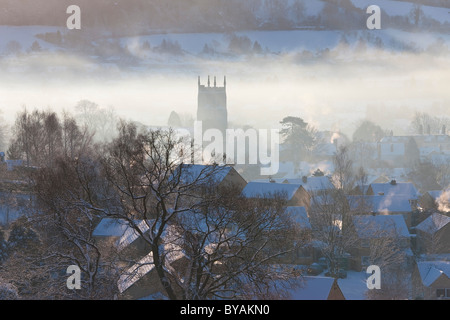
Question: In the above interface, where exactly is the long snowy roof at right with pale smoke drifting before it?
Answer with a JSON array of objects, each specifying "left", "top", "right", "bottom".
[{"left": 347, "top": 195, "right": 412, "bottom": 214}]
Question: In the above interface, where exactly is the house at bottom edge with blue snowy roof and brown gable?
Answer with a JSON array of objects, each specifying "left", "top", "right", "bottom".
[{"left": 289, "top": 276, "right": 345, "bottom": 300}]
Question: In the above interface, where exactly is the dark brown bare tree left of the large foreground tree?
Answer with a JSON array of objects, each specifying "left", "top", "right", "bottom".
[{"left": 32, "top": 154, "right": 118, "bottom": 299}]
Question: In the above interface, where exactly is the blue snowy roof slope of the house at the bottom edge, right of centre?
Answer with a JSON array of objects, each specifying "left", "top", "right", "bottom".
[{"left": 290, "top": 276, "right": 335, "bottom": 300}]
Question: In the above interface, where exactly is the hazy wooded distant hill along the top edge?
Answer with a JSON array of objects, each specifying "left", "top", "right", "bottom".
[{"left": 0, "top": 0, "right": 450, "bottom": 35}]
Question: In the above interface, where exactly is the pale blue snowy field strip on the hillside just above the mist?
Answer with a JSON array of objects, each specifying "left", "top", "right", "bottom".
[{"left": 121, "top": 29, "right": 450, "bottom": 55}]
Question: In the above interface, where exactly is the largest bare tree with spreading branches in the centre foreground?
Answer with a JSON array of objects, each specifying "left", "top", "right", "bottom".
[{"left": 104, "top": 124, "right": 302, "bottom": 299}]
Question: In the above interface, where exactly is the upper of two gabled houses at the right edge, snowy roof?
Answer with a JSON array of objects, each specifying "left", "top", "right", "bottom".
[{"left": 415, "top": 212, "right": 450, "bottom": 254}]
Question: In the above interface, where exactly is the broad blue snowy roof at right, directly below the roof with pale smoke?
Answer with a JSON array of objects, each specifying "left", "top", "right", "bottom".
[{"left": 353, "top": 215, "right": 410, "bottom": 239}]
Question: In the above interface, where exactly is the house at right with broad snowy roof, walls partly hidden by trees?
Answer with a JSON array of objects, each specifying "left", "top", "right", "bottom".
[{"left": 350, "top": 215, "right": 412, "bottom": 271}]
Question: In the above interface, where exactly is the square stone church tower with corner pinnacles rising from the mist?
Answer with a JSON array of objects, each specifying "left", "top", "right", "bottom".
[{"left": 197, "top": 76, "right": 228, "bottom": 136}]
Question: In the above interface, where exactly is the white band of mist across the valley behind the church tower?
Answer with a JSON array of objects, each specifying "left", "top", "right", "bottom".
[{"left": 0, "top": 41, "right": 450, "bottom": 140}]
